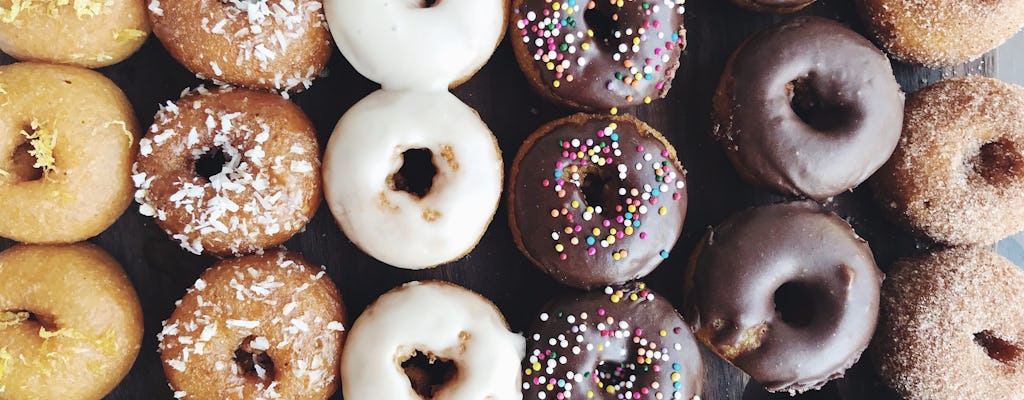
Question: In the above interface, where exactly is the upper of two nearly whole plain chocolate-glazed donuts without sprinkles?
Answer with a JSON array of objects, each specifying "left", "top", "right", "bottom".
[{"left": 713, "top": 16, "right": 903, "bottom": 201}]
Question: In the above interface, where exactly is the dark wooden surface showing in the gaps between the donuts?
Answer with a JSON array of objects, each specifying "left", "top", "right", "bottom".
[{"left": 0, "top": 0, "right": 993, "bottom": 400}]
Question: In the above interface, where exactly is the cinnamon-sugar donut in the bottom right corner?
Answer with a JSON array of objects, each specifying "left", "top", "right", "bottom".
[{"left": 871, "top": 248, "right": 1024, "bottom": 400}]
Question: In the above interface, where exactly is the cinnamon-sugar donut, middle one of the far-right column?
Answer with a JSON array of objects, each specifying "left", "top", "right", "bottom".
[{"left": 872, "top": 77, "right": 1024, "bottom": 245}]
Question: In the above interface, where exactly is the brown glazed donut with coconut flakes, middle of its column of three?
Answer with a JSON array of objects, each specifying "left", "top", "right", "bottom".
[{"left": 131, "top": 87, "right": 321, "bottom": 255}]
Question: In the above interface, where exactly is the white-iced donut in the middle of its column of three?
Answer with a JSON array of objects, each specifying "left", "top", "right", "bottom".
[{"left": 324, "top": 90, "right": 503, "bottom": 269}]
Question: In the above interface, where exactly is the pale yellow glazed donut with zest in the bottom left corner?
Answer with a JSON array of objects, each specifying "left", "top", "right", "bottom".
[{"left": 0, "top": 243, "right": 142, "bottom": 400}]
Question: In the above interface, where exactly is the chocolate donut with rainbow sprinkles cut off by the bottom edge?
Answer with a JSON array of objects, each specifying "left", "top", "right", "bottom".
[{"left": 522, "top": 282, "right": 703, "bottom": 400}]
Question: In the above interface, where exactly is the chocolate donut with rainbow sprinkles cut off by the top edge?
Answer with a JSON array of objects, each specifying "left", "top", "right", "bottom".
[{"left": 509, "top": 0, "right": 686, "bottom": 112}]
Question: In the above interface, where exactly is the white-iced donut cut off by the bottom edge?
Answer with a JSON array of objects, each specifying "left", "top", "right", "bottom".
[{"left": 341, "top": 281, "right": 525, "bottom": 400}]
